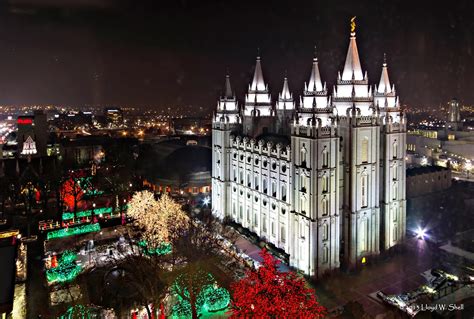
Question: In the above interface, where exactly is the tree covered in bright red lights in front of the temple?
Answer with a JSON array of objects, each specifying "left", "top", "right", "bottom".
[{"left": 231, "top": 250, "right": 326, "bottom": 318}]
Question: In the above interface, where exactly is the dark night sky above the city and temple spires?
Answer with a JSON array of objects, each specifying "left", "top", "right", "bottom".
[{"left": 0, "top": 0, "right": 474, "bottom": 109}]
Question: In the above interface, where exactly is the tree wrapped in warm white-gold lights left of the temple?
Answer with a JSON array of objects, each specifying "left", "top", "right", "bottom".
[{"left": 127, "top": 191, "right": 189, "bottom": 249}]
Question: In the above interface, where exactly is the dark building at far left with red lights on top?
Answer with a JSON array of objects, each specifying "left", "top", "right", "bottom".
[{"left": 17, "top": 111, "right": 49, "bottom": 157}]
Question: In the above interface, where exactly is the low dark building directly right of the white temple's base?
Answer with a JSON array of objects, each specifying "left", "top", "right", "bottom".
[{"left": 407, "top": 166, "right": 451, "bottom": 198}]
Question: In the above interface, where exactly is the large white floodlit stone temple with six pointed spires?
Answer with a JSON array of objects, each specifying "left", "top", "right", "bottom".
[{"left": 212, "top": 23, "right": 406, "bottom": 277}]
